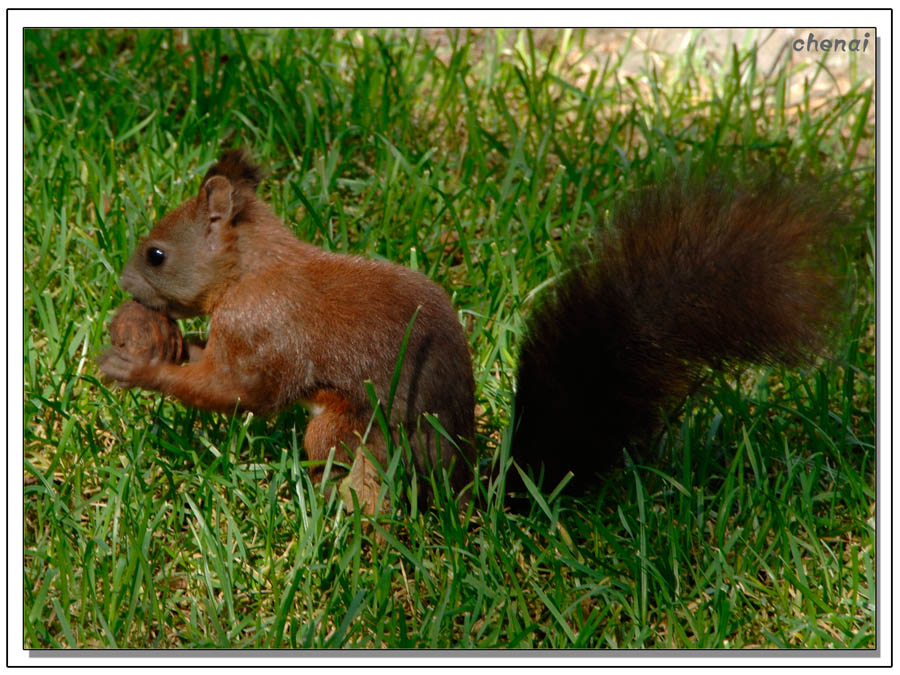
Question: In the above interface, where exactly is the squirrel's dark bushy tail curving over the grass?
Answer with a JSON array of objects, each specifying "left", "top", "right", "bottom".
[{"left": 512, "top": 173, "right": 839, "bottom": 487}]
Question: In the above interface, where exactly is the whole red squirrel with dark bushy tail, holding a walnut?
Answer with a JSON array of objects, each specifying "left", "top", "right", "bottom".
[{"left": 99, "top": 150, "right": 837, "bottom": 512}]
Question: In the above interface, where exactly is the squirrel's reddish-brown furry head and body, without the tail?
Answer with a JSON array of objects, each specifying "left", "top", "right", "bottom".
[{"left": 100, "top": 153, "right": 474, "bottom": 508}]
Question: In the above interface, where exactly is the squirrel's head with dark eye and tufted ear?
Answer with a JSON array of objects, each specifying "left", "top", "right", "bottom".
[{"left": 119, "top": 151, "right": 260, "bottom": 318}]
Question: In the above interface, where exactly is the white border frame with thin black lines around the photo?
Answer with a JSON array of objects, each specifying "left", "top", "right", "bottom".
[{"left": 7, "top": 6, "right": 893, "bottom": 668}]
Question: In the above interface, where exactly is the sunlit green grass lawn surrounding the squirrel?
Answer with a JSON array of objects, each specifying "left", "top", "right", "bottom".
[{"left": 23, "top": 30, "right": 876, "bottom": 649}]
